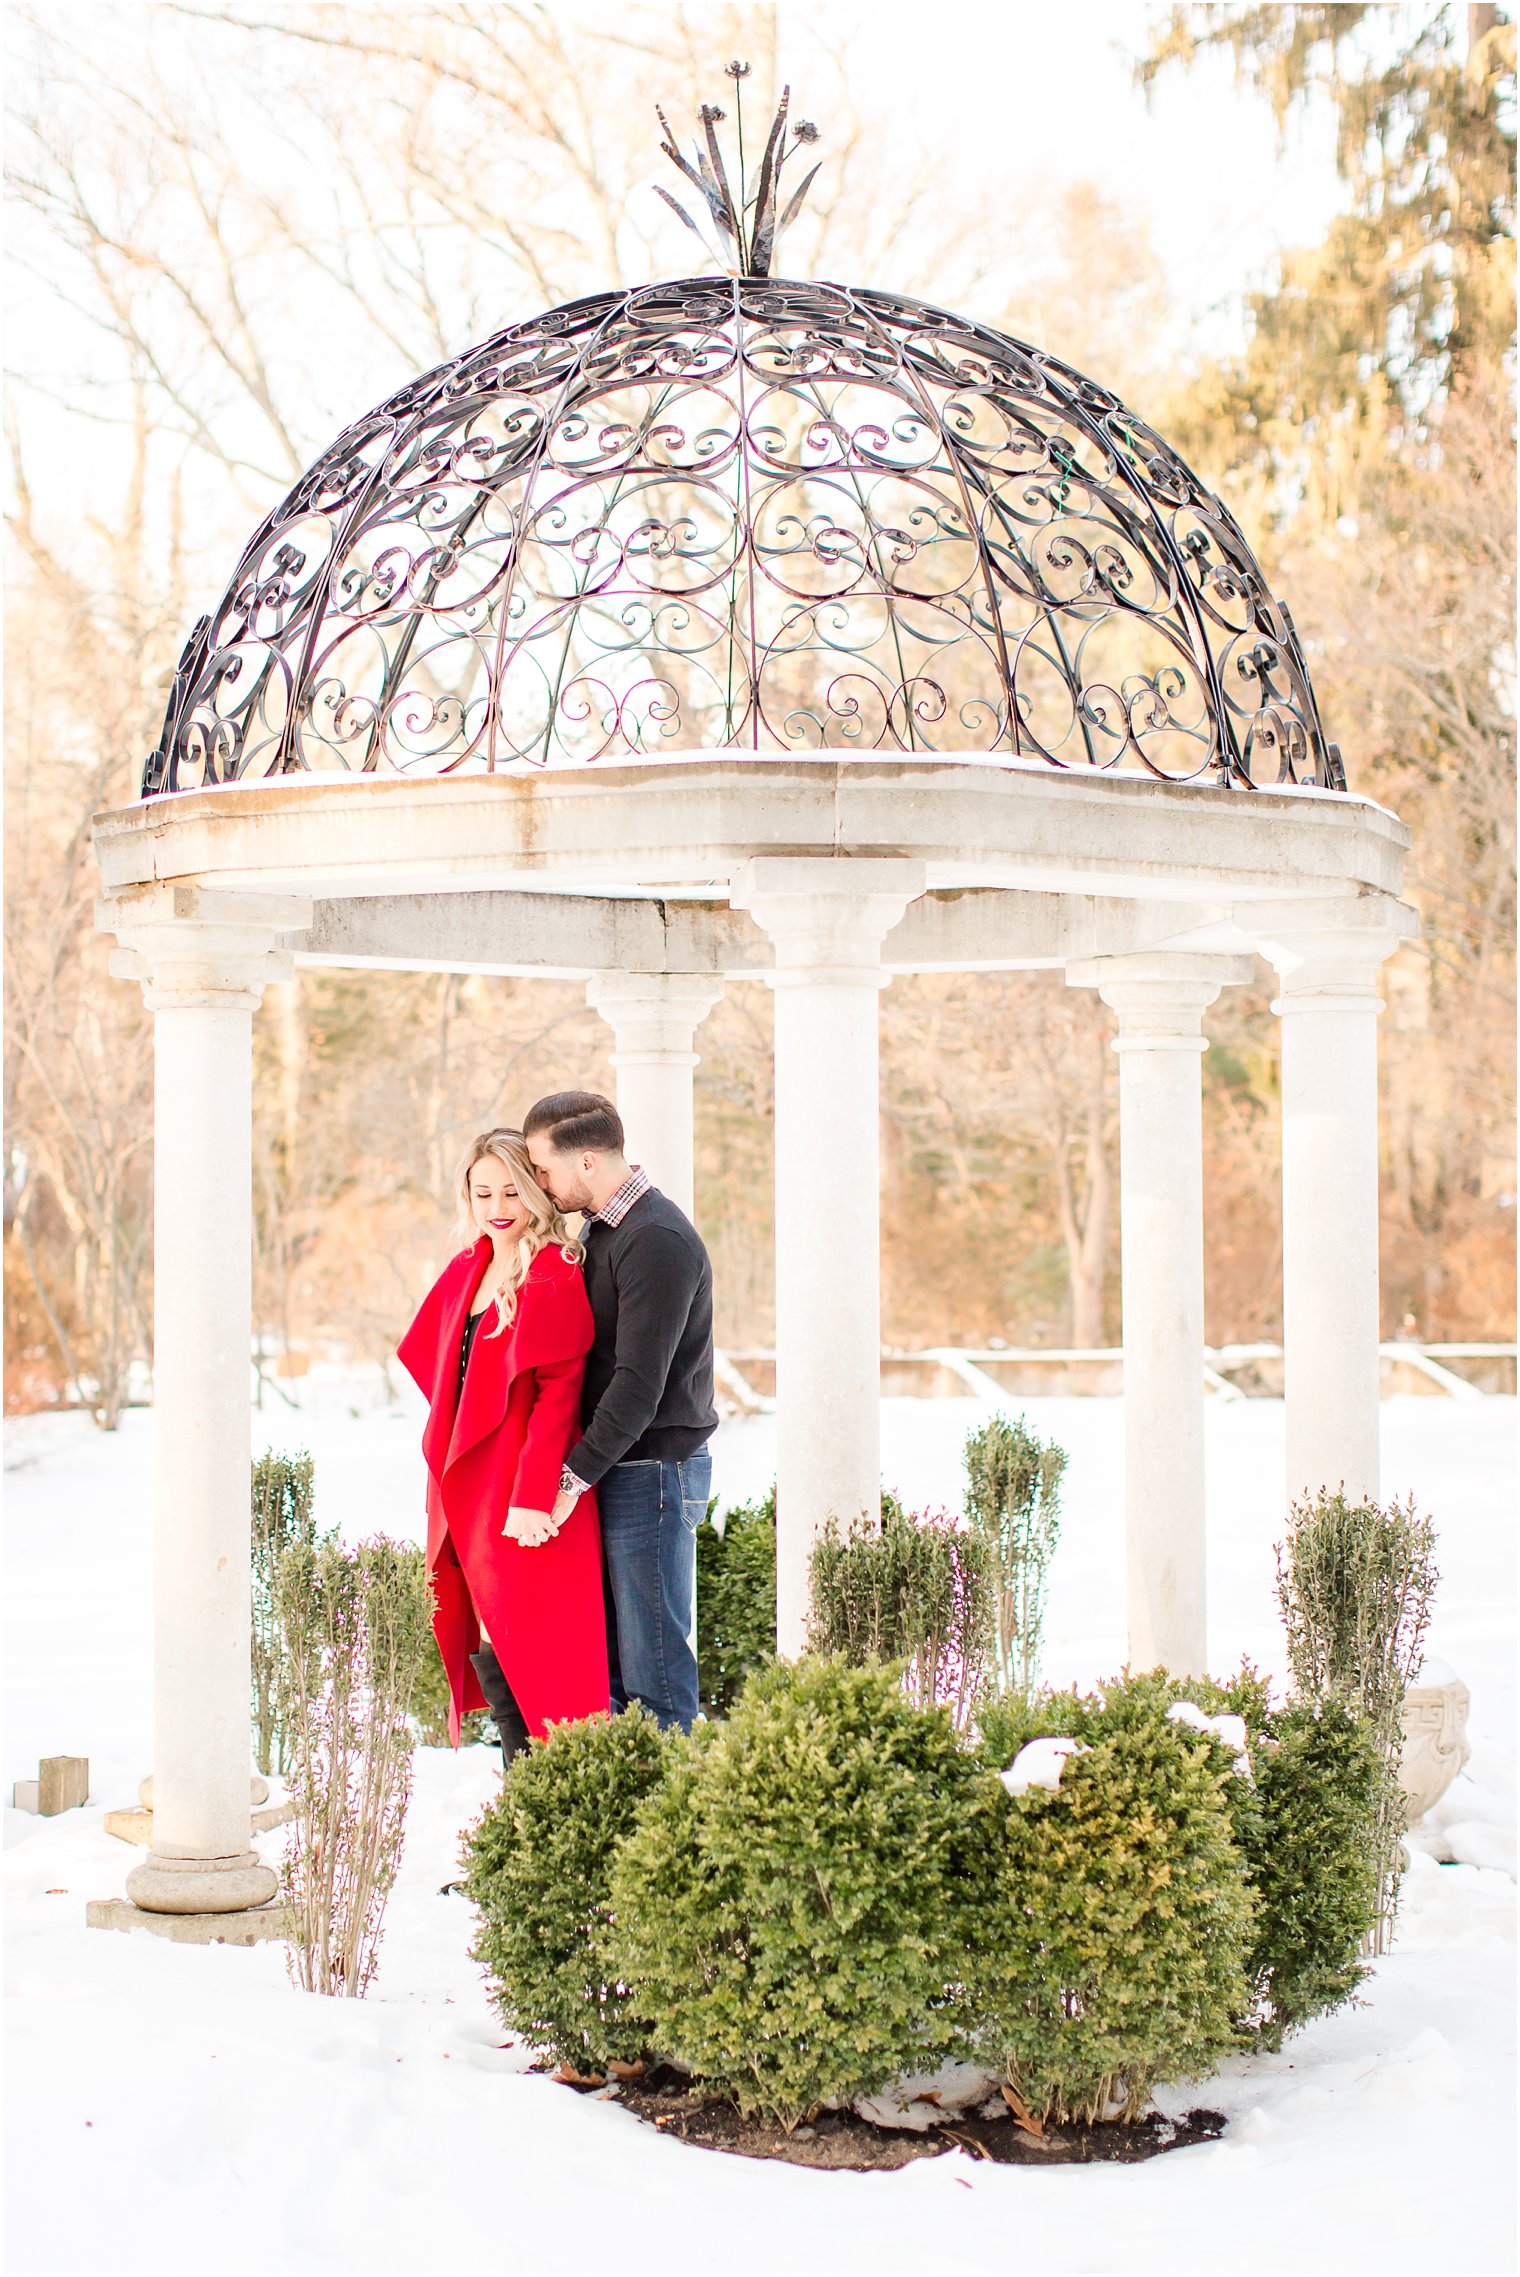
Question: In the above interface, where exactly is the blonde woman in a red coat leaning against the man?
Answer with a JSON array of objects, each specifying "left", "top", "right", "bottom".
[{"left": 398, "top": 1129, "right": 608, "bottom": 1756}]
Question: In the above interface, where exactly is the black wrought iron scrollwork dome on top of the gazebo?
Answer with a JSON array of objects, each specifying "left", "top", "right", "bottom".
[{"left": 143, "top": 84, "right": 1345, "bottom": 797}]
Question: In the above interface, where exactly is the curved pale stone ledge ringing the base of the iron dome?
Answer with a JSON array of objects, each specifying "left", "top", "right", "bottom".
[{"left": 96, "top": 754, "right": 1409, "bottom": 904}]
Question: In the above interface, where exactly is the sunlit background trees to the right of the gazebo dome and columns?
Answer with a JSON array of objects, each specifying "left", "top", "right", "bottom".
[{"left": 1140, "top": 5, "right": 1515, "bottom": 1337}]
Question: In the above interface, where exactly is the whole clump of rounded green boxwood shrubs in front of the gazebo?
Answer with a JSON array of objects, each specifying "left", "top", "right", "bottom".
[{"left": 466, "top": 1658, "right": 1377, "bottom": 2129}]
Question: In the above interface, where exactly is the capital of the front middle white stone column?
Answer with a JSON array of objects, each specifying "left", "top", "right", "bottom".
[{"left": 728, "top": 854, "right": 928, "bottom": 988}]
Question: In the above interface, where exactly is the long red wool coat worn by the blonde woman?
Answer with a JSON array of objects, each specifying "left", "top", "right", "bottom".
[{"left": 398, "top": 1236, "right": 608, "bottom": 1746}]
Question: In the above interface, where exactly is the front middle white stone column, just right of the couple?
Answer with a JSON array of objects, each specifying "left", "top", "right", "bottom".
[{"left": 730, "top": 856, "right": 926, "bottom": 1658}]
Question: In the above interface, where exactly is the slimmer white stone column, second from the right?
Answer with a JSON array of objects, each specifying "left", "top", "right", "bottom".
[{"left": 1067, "top": 952, "right": 1251, "bottom": 1676}]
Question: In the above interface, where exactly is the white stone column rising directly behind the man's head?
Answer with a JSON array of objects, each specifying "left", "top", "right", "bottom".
[{"left": 585, "top": 972, "right": 724, "bottom": 1218}]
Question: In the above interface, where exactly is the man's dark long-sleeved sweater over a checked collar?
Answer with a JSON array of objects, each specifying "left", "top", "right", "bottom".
[{"left": 564, "top": 1186, "right": 717, "bottom": 1487}]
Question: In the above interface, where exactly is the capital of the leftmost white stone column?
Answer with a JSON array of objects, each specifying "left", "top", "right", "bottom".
[{"left": 96, "top": 886, "right": 312, "bottom": 1011}]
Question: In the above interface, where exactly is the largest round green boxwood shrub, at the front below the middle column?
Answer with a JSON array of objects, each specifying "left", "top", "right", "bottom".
[{"left": 610, "top": 1660, "right": 1003, "bottom": 2129}]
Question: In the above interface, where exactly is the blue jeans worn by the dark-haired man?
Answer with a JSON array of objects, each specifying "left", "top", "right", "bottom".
[{"left": 596, "top": 1448, "right": 712, "bottom": 1731}]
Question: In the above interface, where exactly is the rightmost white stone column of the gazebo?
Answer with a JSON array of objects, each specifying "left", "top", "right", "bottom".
[{"left": 1236, "top": 895, "right": 1418, "bottom": 1501}]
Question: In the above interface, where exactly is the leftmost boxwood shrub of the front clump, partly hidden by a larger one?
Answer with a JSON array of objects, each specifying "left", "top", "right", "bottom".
[{"left": 464, "top": 1708, "right": 669, "bottom": 2072}]
